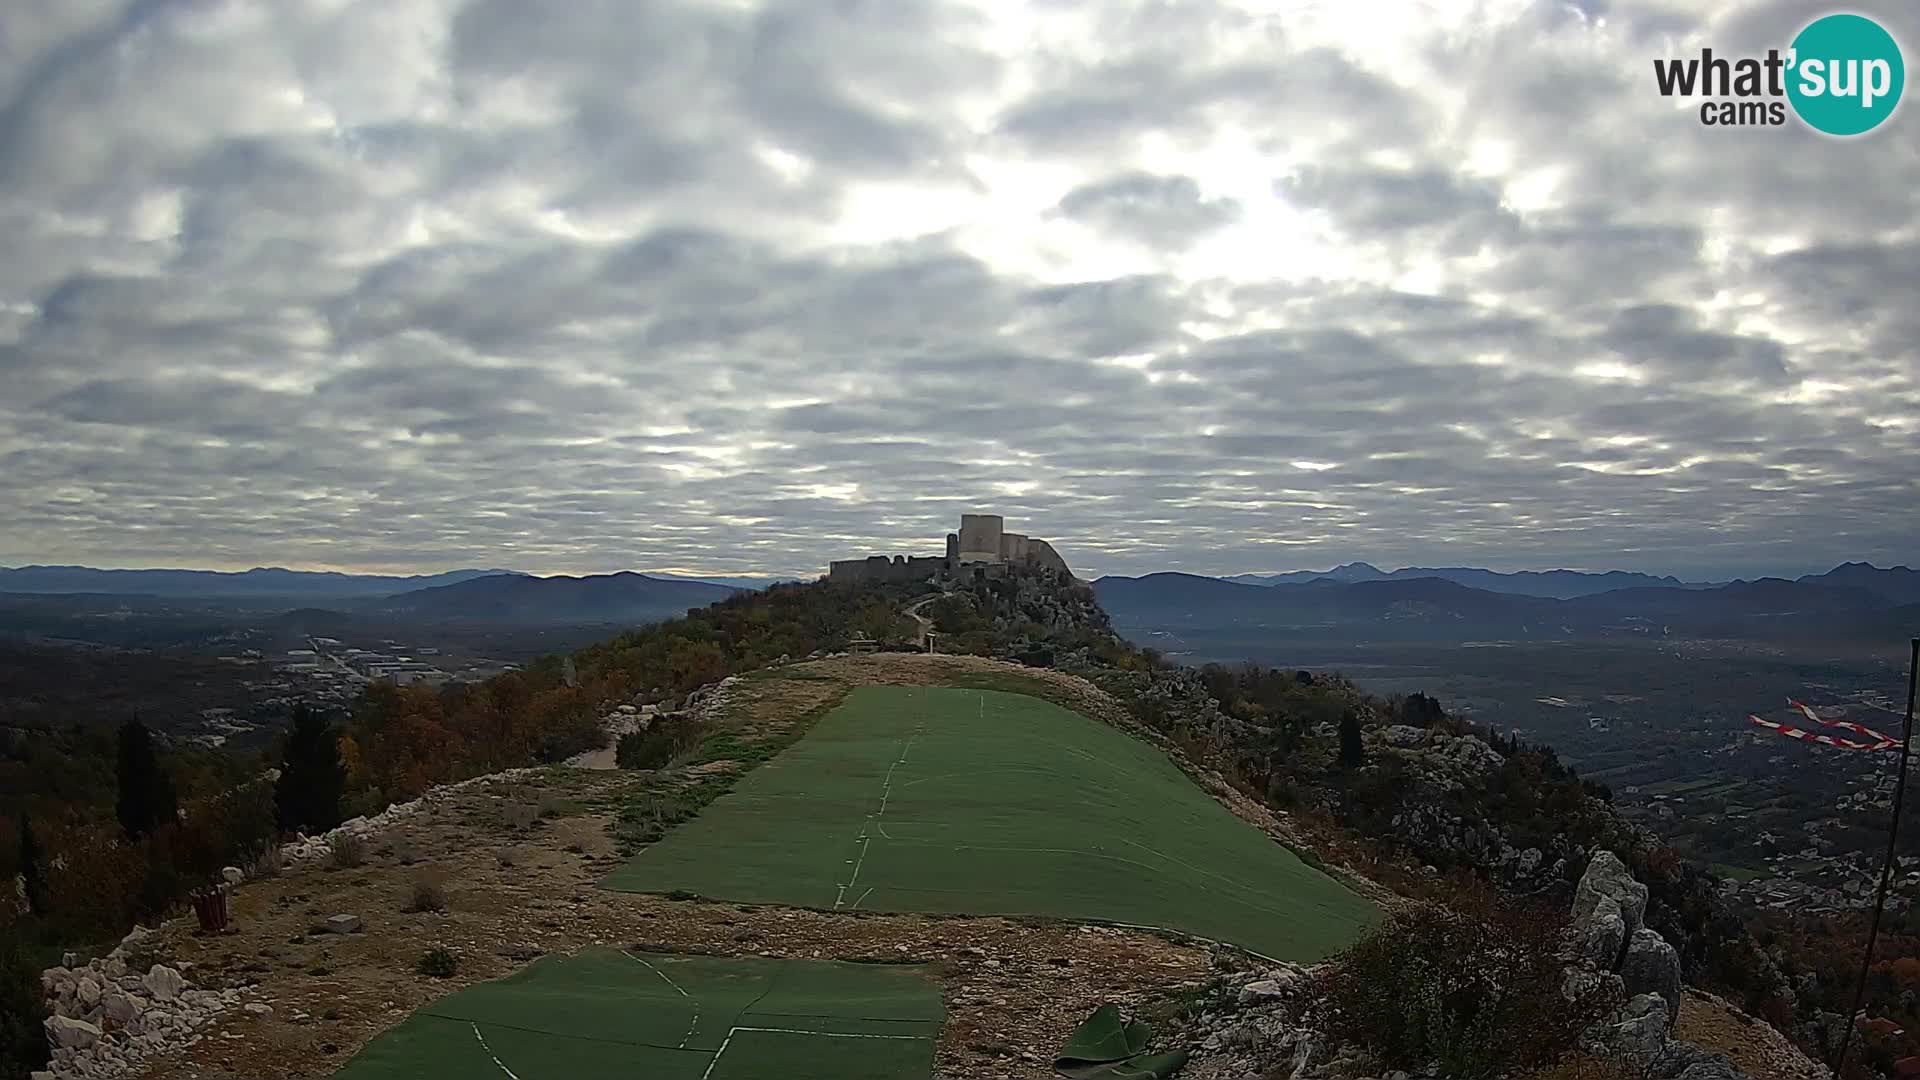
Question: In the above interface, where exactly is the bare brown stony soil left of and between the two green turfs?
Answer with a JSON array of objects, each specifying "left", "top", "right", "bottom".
[{"left": 146, "top": 657, "right": 1210, "bottom": 1080}]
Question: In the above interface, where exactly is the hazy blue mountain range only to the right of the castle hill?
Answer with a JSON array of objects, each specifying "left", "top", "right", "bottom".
[{"left": 1094, "top": 563, "right": 1920, "bottom": 640}]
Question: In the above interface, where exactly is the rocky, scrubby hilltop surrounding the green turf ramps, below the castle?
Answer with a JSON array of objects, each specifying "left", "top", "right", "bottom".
[{"left": 18, "top": 569, "right": 1820, "bottom": 1080}]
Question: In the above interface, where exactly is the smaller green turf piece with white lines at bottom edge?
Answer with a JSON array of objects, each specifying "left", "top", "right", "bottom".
[{"left": 334, "top": 949, "right": 945, "bottom": 1080}]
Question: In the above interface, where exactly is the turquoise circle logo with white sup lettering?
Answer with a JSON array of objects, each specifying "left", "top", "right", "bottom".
[{"left": 1788, "top": 15, "right": 1907, "bottom": 135}]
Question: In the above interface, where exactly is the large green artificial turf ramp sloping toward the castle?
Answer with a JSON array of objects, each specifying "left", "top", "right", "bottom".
[{"left": 605, "top": 686, "right": 1377, "bottom": 961}]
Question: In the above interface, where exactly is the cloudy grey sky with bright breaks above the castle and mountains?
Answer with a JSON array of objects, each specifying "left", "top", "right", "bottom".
[{"left": 0, "top": 0, "right": 1920, "bottom": 577}]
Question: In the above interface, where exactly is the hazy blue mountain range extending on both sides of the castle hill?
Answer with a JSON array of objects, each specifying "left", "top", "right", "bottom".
[{"left": 0, "top": 563, "right": 1920, "bottom": 640}]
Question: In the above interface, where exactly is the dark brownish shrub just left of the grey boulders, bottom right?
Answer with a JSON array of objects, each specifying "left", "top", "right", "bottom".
[{"left": 1315, "top": 890, "right": 1615, "bottom": 1078}]
